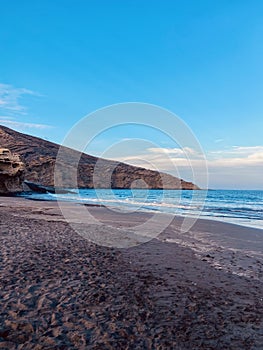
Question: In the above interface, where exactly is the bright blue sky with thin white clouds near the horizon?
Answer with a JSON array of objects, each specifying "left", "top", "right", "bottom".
[{"left": 0, "top": 0, "right": 263, "bottom": 189}]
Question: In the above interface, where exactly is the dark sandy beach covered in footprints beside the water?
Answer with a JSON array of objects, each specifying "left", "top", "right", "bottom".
[{"left": 0, "top": 197, "right": 263, "bottom": 350}]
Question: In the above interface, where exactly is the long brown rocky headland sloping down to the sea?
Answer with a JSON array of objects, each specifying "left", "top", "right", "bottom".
[{"left": 0, "top": 126, "right": 199, "bottom": 190}]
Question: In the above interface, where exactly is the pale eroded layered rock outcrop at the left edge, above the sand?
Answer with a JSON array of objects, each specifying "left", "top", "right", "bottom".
[{"left": 0, "top": 148, "right": 25, "bottom": 195}]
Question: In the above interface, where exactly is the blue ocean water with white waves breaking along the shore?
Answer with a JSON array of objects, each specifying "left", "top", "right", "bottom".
[{"left": 20, "top": 189, "right": 263, "bottom": 229}]
